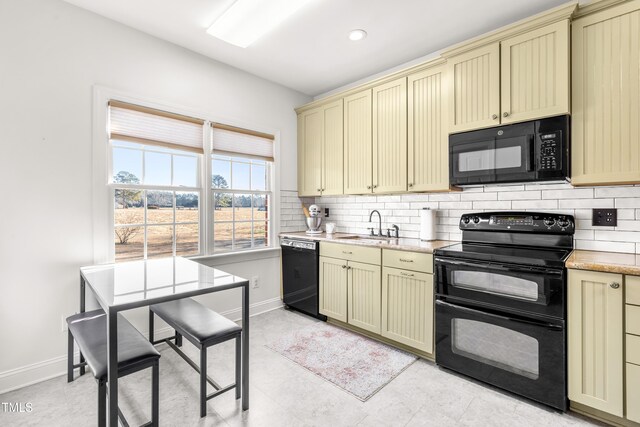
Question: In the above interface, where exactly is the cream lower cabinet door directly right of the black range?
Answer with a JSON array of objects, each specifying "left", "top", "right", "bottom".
[{"left": 567, "top": 270, "right": 624, "bottom": 417}]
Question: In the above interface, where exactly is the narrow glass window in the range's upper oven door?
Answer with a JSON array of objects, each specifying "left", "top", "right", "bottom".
[{"left": 451, "top": 270, "right": 538, "bottom": 301}]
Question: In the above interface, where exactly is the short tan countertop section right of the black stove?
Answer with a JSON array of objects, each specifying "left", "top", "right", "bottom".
[{"left": 565, "top": 250, "right": 640, "bottom": 275}]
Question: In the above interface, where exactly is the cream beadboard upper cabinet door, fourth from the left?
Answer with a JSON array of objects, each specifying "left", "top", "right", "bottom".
[{"left": 373, "top": 77, "right": 407, "bottom": 193}]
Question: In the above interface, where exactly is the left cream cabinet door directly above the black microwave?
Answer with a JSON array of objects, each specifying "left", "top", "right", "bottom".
[{"left": 447, "top": 42, "right": 500, "bottom": 132}]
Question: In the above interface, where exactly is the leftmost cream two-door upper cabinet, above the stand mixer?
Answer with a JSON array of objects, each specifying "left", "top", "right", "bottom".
[{"left": 298, "top": 100, "right": 343, "bottom": 196}]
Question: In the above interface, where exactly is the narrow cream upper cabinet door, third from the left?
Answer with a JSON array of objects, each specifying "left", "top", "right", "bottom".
[{"left": 344, "top": 89, "right": 373, "bottom": 194}]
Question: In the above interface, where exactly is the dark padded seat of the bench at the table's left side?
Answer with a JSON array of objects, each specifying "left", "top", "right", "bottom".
[{"left": 67, "top": 310, "right": 160, "bottom": 379}]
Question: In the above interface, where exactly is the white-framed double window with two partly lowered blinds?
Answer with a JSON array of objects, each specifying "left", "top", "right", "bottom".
[{"left": 108, "top": 101, "right": 273, "bottom": 261}]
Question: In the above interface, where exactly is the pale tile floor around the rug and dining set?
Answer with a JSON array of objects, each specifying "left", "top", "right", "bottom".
[{"left": 0, "top": 309, "right": 599, "bottom": 427}]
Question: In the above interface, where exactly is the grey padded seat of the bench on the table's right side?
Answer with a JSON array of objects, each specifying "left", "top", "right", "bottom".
[{"left": 149, "top": 298, "right": 242, "bottom": 344}]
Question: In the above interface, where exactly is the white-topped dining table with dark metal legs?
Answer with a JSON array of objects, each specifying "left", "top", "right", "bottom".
[{"left": 80, "top": 256, "right": 249, "bottom": 426}]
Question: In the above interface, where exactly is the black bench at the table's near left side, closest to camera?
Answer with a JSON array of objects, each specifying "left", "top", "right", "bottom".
[{"left": 67, "top": 310, "right": 160, "bottom": 427}]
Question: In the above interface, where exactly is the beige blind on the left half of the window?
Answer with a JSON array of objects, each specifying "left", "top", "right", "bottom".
[{"left": 109, "top": 100, "right": 204, "bottom": 153}]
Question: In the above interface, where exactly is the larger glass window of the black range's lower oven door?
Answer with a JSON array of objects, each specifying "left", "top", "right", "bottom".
[{"left": 451, "top": 318, "right": 540, "bottom": 380}]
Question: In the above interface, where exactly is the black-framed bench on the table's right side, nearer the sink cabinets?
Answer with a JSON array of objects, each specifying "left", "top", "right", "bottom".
[{"left": 149, "top": 298, "right": 242, "bottom": 417}]
